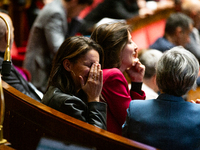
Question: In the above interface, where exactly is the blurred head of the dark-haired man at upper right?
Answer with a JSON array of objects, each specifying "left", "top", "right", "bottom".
[{"left": 165, "top": 13, "right": 193, "bottom": 46}]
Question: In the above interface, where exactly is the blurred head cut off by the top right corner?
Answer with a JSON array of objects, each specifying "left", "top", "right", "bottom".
[{"left": 181, "top": 0, "right": 200, "bottom": 30}]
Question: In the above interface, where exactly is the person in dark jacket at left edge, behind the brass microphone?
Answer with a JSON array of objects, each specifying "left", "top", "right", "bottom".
[{"left": 0, "top": 10, "right": 43, "bottom": 101}]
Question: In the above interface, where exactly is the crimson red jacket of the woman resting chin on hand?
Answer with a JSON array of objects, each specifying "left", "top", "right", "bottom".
[{"left": 101, "top": 68, "right": 145, "bottom": 135}]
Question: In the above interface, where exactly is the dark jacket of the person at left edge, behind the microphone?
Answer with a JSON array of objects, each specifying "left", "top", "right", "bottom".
[{"left": 0, "top": 52, "right": 41, "bottom": 101}]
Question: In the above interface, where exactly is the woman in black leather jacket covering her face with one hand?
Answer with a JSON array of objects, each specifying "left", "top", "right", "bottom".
[{"left": 42, "top": 36, "right": 106, "bottom": 129}]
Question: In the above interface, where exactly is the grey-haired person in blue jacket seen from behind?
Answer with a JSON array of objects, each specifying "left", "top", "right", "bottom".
[{"left": 122, "top": 46, "right": 200, "bottom": 150}]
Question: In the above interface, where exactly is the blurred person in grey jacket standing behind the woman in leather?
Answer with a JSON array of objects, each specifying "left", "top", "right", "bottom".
[{"left": 24, "top": 0, "right": 93, "bottom": 92}]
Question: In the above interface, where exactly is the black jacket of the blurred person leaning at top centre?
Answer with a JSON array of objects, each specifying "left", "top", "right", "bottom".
[{"left": 80, "top": 0, "right": 139, "bottom": 34}]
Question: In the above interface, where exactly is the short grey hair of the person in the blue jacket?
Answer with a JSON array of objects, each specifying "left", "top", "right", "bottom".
[{"left": 156, "top": 46, "right": 199, "bottom": 96}]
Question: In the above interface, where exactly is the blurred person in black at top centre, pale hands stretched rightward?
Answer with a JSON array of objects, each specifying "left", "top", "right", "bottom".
[{"left": 80, "top": 0, "right": 174, "bottom": 35}]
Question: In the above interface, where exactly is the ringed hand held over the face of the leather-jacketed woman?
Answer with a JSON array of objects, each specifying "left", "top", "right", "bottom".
[{"left": 80, "top": 63, "right": 103, "bottom": 102}]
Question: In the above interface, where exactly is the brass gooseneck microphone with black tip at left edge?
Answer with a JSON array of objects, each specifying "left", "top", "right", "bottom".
[{"left": 0, "top": 15, "right": 11, "bottom": 76}]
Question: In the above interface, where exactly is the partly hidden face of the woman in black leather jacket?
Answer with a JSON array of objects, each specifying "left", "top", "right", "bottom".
[{"left": 71, "top": 49, "right": 99, "bottom": 90}]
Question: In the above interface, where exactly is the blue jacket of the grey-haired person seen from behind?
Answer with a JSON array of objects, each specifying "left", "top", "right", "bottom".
[{"left": 123, "top": 94, "right": 200, "bottom": 150}]
